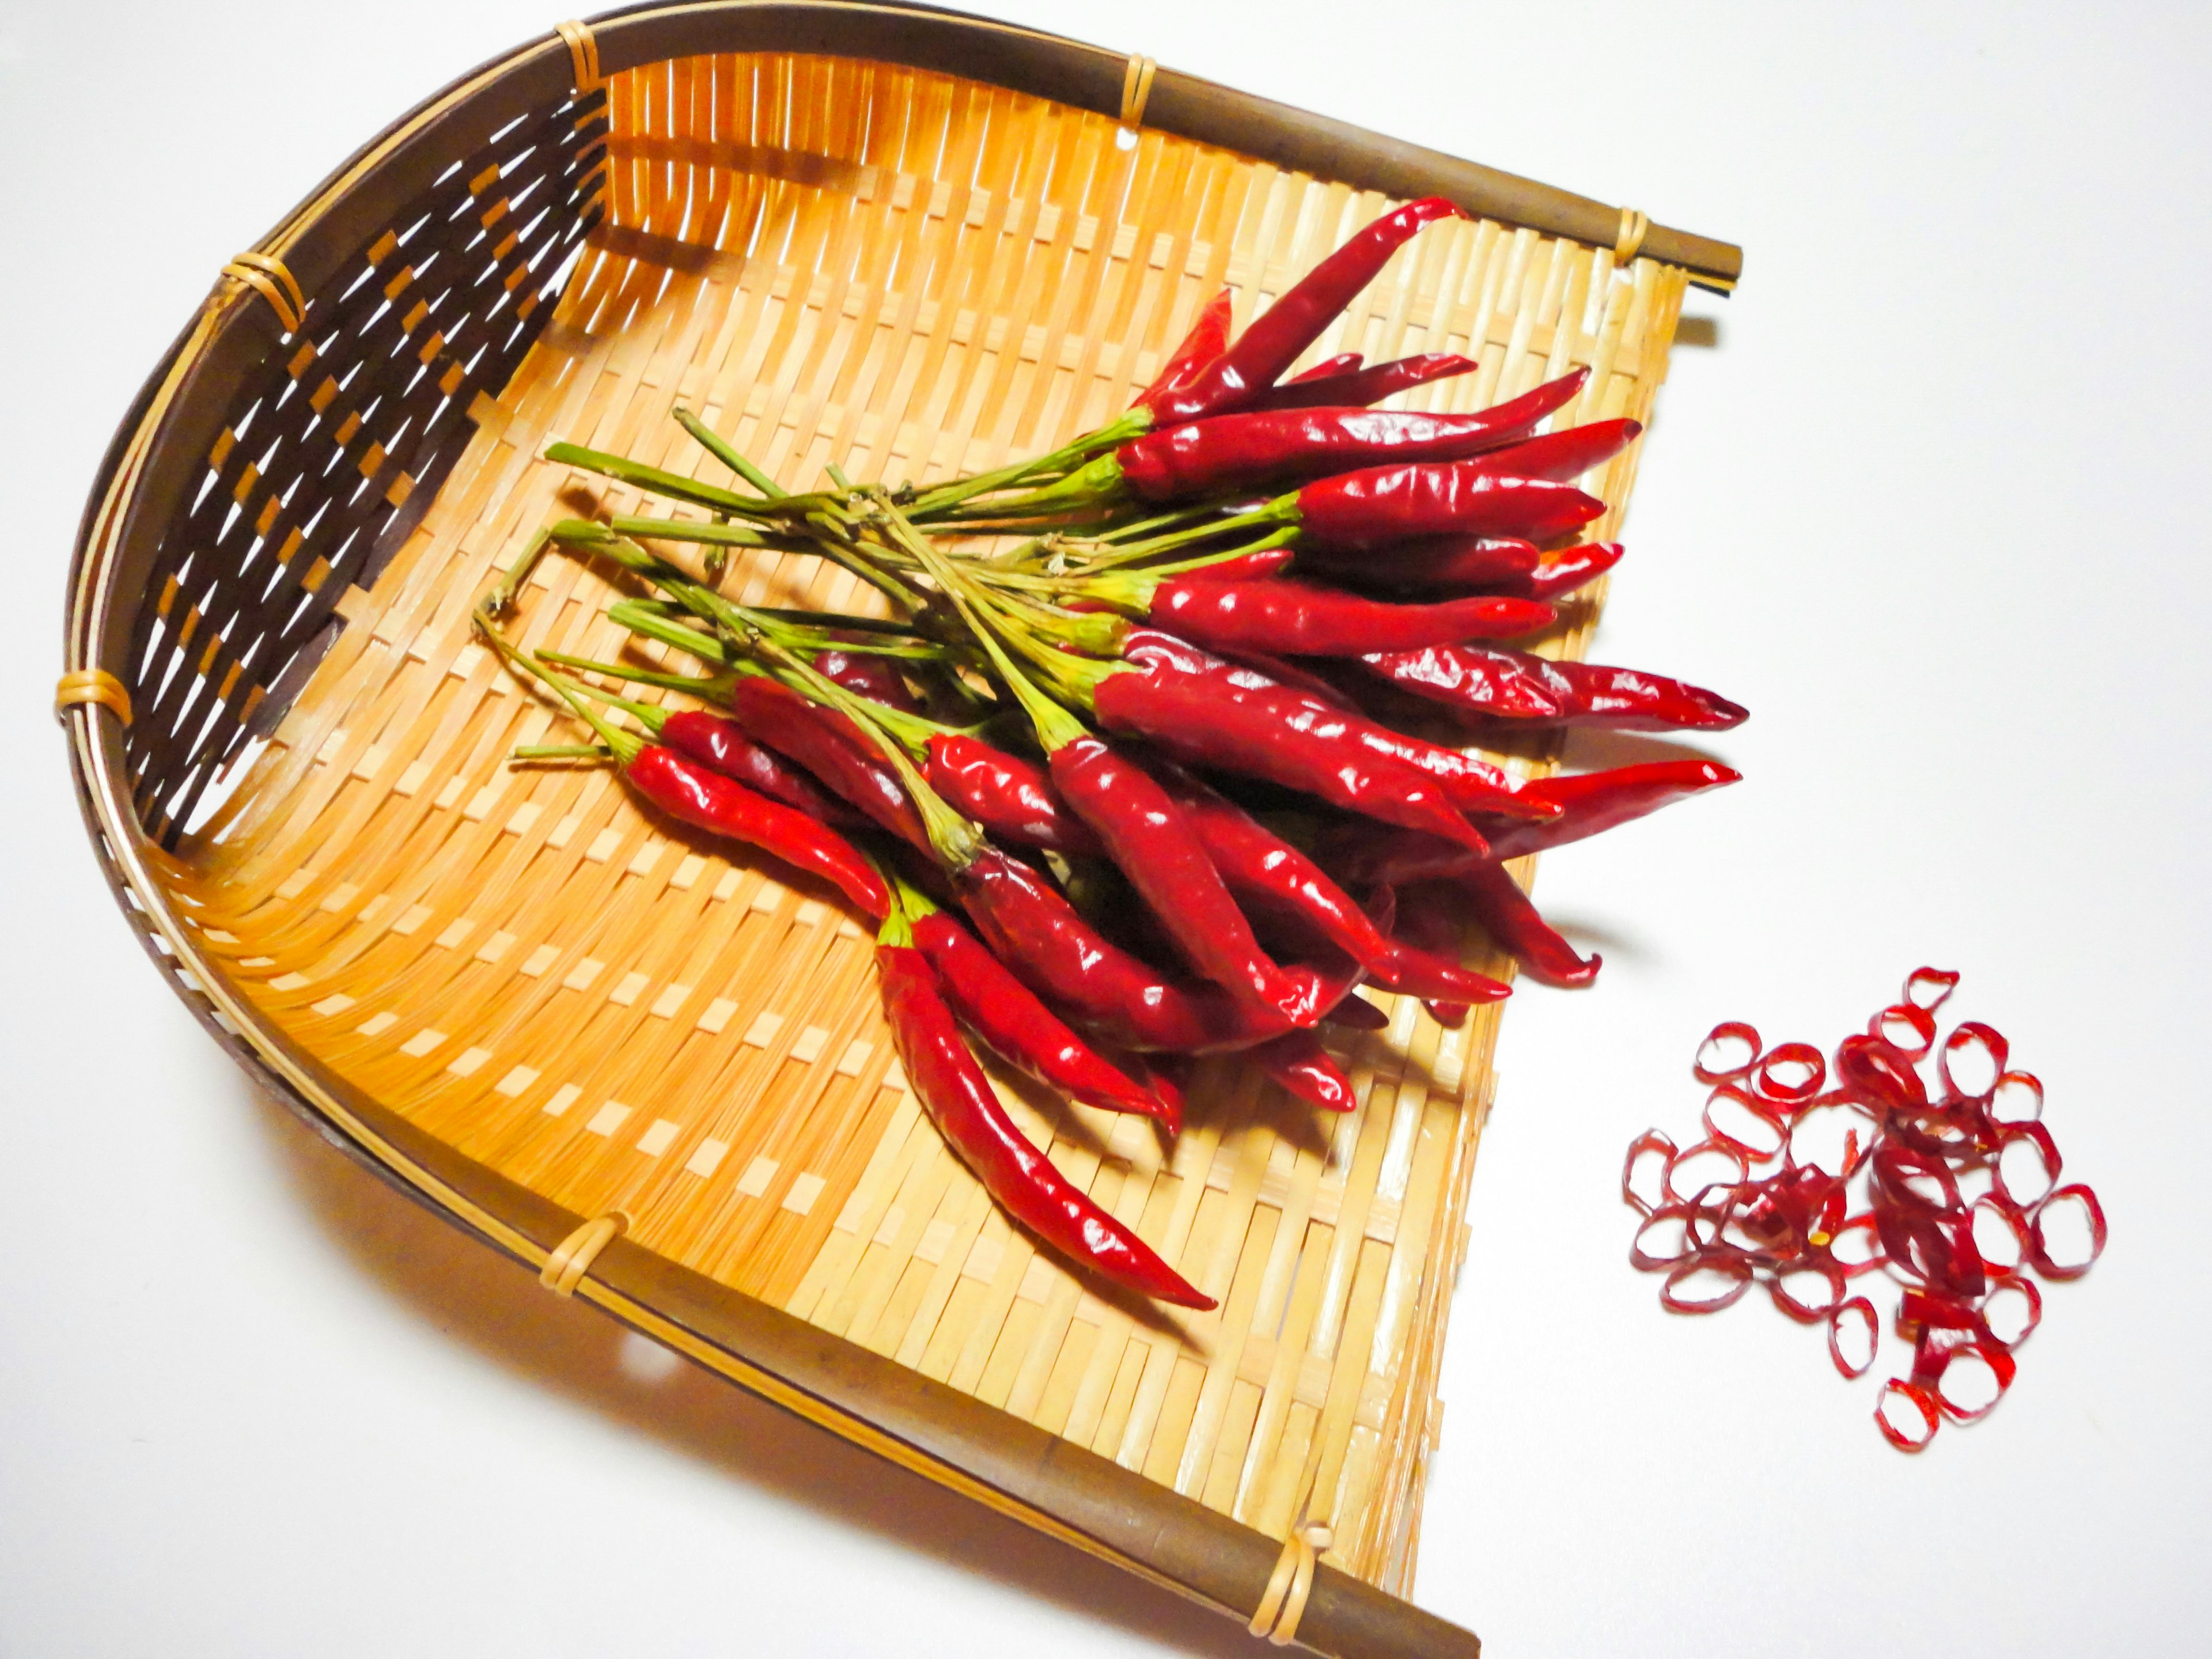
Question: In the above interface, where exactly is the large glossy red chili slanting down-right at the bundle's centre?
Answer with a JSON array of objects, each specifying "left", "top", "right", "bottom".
[{"left": 1093, "top": 666, "right": 1482, "bottom": 845}]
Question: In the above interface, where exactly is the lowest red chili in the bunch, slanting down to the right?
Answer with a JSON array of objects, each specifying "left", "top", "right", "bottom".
[{"left": 876, "top": 942, "right": 1217, "bottom": 1309}]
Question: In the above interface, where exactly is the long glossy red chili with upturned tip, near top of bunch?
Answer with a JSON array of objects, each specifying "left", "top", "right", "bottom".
[{"left": 1115, "top": 372, "right": 1592, "bottom": 502}]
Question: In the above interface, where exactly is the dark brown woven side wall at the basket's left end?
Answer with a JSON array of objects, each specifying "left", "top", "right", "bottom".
[{"left": 126, "top": 90, "right": 606, "bottom": 847}]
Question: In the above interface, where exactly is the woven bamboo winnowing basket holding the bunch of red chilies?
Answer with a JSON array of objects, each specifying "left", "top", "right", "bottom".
[{"left": 60, "top": 5, "right": 1738, "bottom": 1654}]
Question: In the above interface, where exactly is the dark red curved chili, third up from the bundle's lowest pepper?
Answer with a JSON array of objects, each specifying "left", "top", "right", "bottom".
[{"left": 958, "top": 851, "right": 1354, "bottom": 1053}]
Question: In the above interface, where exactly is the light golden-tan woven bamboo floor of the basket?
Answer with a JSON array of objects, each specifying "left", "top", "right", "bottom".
[{"left": 132, "top": 55, "right": 1683, "bottom": 1593}]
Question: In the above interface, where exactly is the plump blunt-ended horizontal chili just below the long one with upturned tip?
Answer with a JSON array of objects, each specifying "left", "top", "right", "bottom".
[{"left": 1274, "top": 460, "right": 1606, "bottom": 551}]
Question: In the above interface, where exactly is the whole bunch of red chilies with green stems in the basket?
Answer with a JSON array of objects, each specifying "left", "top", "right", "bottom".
[{"left": 478, "top": 199, "right": 1743, "bottom": 1307}]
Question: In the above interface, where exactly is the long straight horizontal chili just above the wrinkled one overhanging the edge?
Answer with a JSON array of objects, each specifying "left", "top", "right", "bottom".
[{"left": 1150, "top": 575, "right": 1557, "bottom": 657}]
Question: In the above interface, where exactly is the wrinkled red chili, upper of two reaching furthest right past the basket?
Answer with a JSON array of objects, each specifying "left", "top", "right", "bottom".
[{"left": 1361, "top": 646, "right": 1749, "bottom": 732}]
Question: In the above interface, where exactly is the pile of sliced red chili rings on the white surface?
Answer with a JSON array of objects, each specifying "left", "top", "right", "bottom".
[{"left": 1622, "top": 969, "right": 2106, "bottom": 1451}]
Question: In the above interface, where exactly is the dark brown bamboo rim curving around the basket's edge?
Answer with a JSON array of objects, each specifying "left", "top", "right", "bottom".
[{"left": 64, "top": 0, "right": 1741, "bottom": 1654}]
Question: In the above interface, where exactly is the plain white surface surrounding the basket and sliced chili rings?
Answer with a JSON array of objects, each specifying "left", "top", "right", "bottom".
[{"left": 0, "top": 0, "right": 2212, "bottom": 1659}]
